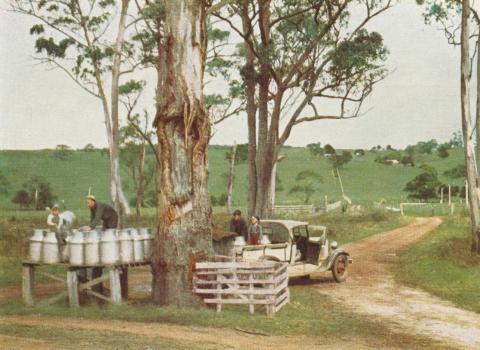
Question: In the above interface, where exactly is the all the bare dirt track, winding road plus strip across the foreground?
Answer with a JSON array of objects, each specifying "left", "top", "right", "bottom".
[{"left": 0, "top": 218, "right": 480, "bottom": 350}]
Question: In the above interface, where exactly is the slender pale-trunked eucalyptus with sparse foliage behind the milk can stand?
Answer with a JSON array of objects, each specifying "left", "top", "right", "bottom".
[{"left": 10, "top": 0, "right": 141, "bottom": 219}]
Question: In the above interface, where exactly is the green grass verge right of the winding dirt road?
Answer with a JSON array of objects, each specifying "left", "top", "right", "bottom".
[{"left": 394, "top": 216, "right": 480, "bottom": 312}]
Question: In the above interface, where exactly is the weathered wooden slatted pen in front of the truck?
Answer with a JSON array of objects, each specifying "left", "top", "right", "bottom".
[{"left": 193, "top": 261, "right": 290, "bottom": 316}]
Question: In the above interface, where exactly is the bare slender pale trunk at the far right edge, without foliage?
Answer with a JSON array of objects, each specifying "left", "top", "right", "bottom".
[{"left": 460, "top": 0, "right": 480, "bottom": 254}]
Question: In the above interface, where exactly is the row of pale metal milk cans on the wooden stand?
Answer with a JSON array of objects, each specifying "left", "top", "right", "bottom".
[{"left": 30, "top": 228, "right": 153, "bottom": 266}]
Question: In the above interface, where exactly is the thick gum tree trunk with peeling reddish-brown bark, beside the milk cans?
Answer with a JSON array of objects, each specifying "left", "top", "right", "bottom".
[{"left": 152, "top": 0, "right": 212, "bottom": 306}]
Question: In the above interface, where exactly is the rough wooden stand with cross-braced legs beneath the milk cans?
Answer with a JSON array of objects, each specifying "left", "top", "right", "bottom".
[{"left": 22, "top": 261, "right": 150, "bottom": 307}]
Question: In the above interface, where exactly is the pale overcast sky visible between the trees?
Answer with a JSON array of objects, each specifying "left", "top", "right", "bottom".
[{"left": 0, "top": 0, "right": 461, "bottom": 149}]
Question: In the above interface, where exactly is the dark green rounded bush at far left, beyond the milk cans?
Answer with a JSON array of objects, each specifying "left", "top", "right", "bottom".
[{"left": 12, "top": 177, "right": 56, "bottom": 210}]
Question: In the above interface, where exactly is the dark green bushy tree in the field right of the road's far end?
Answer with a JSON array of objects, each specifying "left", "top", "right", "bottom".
[{"left": 405, "top": 164, "right": 441, "bottom": 200}]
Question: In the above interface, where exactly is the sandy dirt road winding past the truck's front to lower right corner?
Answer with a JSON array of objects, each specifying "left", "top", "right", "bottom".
[{"left": 316, "top": 218, "right": 480, "bottom": 349}]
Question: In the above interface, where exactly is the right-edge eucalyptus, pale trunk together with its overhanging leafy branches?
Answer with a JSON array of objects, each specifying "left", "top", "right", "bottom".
[{"left": 417, "top": 0, "right": 480, "bottom": 254}]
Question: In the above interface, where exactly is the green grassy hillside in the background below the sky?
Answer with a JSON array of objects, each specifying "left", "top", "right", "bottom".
[{"left": 0, "top": 146, "right": 463, "bottom": 210}]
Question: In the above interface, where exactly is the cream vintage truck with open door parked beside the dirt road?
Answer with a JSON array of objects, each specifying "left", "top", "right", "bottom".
[{"left": 234, "top": 220, "right": 352, "bottom": 282}]
